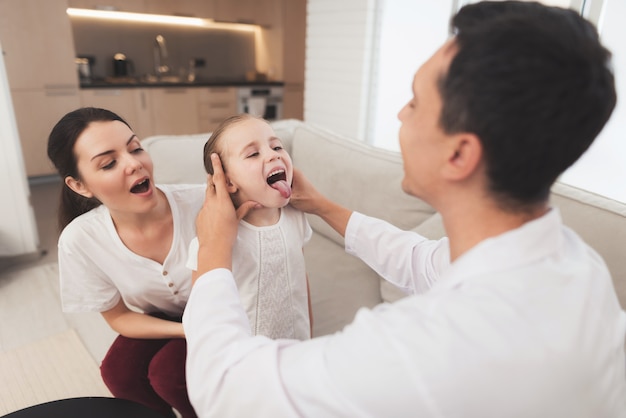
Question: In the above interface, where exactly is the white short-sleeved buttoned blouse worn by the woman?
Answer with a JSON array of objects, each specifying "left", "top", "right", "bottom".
[{"left": 58, "top": 185, "right": 206, "bottom": 316}]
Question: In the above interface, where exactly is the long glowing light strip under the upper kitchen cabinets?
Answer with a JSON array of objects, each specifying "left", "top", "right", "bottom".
[{"left": 67, "top": 7, "right": 258, "bottom": 32}]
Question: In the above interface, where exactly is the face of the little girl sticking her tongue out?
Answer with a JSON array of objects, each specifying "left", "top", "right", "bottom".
[{"left": 220, "top": 119, "right": 293, "bottom": 208}]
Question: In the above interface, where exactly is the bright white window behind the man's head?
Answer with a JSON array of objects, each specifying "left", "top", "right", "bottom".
[{"left": 365, "top": 0, "right": 626, "bottom": 202}]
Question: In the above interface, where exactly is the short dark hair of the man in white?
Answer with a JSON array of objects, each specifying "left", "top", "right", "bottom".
[{"left": 439, "top": 1, "right": 616, "bottom": 210}]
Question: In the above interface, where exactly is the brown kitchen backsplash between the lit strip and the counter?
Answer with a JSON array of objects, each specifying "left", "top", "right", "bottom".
[{"left": 71, "top": 17, "right": 255, "bottom": 80}]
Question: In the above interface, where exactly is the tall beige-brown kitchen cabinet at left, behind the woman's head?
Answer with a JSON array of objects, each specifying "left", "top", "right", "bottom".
[{"left": 0, "top": 0, "right": 80, "bottom": 177}]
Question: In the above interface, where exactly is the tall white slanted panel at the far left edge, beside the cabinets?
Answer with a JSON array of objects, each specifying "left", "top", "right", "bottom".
[{"left": 0, "top": 40, "right": 39, "bottom": 256}]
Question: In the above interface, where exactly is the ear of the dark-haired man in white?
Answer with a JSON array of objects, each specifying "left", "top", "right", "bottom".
[{"left": 444, "top": 133, "right": 483, "bottom": 180}]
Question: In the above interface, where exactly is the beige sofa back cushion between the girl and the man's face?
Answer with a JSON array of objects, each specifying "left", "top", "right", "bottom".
[{"left": 291, "top": 124, "right": 434, "bottom": 246}]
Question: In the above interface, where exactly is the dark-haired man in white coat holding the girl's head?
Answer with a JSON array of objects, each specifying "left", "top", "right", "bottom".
[{"left": 183, "top": 2, "right": 626, "bottom": 418}]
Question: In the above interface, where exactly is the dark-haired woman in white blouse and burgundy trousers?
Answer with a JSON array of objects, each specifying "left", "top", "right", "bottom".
[{"left": 48, "top": 108, "right": 205, "bottom": 418}]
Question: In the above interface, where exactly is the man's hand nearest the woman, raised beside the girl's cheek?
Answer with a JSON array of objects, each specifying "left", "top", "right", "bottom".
[{"left": 196, "top": 154, "right": 259, "bottom": 277}]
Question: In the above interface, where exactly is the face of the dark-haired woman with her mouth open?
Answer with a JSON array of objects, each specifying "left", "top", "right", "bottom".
[{"left": 65, "top": 121, "right": 157, "bottom": 214}]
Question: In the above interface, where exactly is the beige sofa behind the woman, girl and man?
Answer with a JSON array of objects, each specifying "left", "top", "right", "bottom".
[{"left": 143, "top": 120, "right": 626, "bottom": 335}]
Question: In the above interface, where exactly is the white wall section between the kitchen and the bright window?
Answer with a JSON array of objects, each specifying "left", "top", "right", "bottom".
[{"left": 304, "top": 0, "right": 376, "bottom": 139}]
